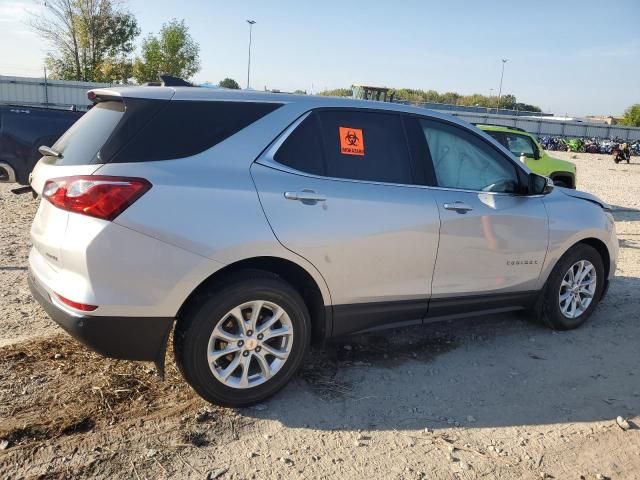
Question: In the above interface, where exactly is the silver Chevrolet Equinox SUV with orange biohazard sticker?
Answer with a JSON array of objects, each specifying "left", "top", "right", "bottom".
[{"left": 29, "top": 87, "right": 618, "bottom": 406}]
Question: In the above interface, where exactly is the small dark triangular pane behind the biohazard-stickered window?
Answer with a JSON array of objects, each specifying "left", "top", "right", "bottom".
[{"left": 274, "top": 113, "right": 325, "bottom": 175}]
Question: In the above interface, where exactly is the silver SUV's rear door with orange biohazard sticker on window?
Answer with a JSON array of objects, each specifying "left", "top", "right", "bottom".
[{"left": 251, "top": 109, "right": 439, "bottom": 335}]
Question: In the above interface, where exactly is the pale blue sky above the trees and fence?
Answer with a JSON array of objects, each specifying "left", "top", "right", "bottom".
[{"left": 0, "top": 0, "right": 640, "bottom": 115}]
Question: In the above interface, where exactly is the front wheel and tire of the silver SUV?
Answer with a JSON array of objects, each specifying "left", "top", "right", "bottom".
[{"left": 541, "top": 244, "right": 606, "bottom": 330}]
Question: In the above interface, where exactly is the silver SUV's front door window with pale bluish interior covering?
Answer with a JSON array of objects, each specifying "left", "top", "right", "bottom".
[{"left": 421, "top": 120, "right": 518, "bottom": 193}]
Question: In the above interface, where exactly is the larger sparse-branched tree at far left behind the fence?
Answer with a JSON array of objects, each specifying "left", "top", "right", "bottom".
[{"left": 30, "top": 0, "right": 140, "bottom": 83}]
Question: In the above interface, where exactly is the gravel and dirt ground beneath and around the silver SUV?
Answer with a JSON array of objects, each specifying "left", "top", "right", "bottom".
[{"left": 0, "top": 152, "right": 640, "bottom": 480}]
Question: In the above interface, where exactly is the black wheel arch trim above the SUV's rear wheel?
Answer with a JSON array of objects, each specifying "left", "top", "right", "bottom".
[{"left": 176, "top": 256, "right": 332, "bottom": 343}]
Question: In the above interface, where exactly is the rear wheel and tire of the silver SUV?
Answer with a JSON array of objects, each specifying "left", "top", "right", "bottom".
[{"left": 174, "top": 272, "right": 311, "bottom": 407}]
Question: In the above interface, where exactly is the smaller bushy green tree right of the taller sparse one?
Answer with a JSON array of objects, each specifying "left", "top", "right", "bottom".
[{"left": 133, "top": 19, "right": 200, "bottom": 83}]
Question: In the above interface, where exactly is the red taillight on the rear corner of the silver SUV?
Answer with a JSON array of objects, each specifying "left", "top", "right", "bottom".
[{"left": 42, "top": 175, "right": 151, "bottom": 221}]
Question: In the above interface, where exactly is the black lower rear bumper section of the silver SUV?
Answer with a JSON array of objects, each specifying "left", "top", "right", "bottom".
[{"left": 28, "top": 272, "right": 173, "bottom": 364}]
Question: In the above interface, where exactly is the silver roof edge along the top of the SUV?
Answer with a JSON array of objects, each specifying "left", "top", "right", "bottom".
[{"left": 90, "top": 86, "right": 476, "bottom": 128}]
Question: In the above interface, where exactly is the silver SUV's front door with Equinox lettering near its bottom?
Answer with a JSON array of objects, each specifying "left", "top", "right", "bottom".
[{"left": 412, "top": 119, "right": 548, "bottom": 306}]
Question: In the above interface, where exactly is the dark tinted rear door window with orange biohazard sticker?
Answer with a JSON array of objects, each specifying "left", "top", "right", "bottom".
[{"left": 318, "top": 110, "right": 413, "bottom": 184}]
